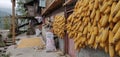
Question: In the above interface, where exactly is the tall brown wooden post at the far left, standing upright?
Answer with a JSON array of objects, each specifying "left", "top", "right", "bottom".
[{"left": 12, "top": 0, "right": 15, "bottom": 44}]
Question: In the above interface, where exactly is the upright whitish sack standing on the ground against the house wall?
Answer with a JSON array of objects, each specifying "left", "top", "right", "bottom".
[{"left": 46, "top": 26, "right": 56, "bottom": 52}]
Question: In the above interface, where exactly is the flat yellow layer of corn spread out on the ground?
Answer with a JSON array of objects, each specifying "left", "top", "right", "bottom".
[{"left": 17, "top": 38, "right": 45, "bottom": 48}]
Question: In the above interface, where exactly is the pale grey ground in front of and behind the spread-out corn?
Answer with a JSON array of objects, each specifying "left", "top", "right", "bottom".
[{"left": 3, "top": 34, "right": 68, "bottom": 57}]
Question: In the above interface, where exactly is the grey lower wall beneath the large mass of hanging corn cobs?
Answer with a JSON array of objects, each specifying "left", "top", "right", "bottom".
[{"left": 77, "top": 47, "right": 119, "bottom": 57}]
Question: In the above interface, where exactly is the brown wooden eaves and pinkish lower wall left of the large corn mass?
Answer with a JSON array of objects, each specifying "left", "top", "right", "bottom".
[{"left": 41, "top": 0, "right": 77, "bottom": 57}]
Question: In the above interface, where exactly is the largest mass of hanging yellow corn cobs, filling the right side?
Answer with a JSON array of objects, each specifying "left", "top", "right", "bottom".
[{"left": 66, "top": 0, "right": 120, "bottom": 57}]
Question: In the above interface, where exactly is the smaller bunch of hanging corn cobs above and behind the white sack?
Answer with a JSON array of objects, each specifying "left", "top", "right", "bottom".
[{"left": 53, "top": 15, "right": 65, "bottom": 38}]
